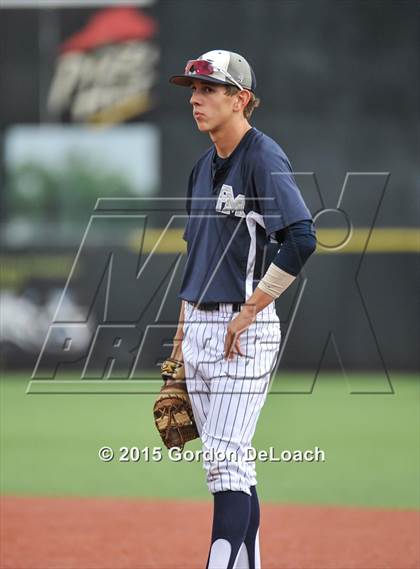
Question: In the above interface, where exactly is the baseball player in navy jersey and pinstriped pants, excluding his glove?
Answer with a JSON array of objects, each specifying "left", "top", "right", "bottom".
[{"left": 170, "top": 50, "right": 316, "bottom": 569}]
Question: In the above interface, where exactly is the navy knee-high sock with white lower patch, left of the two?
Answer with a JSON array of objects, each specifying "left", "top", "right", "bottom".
[{"left": 206, "top": 490, "right": 251, "bottom": 569}]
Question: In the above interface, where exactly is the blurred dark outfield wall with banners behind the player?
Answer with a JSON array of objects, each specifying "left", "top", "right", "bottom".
[{"left": 0, "top": 0, "right": 420, "bottom": 374}]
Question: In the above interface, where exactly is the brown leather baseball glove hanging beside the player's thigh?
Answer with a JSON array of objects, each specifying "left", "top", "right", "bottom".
[{"left": 153, "top": 358, "right": 198, "bottom": 449}]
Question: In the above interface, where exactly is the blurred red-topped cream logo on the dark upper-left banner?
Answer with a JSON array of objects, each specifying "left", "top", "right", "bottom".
[{"left": 48, "top": 8, "right": 159, "bottom": 123}]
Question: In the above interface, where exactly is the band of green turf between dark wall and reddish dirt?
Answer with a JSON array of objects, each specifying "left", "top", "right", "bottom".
[{"left": 0, "top": 374, "right": 420, "bottom": 508}]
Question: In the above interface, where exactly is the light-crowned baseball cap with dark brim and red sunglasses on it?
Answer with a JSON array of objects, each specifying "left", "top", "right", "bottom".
[{"left": 169, "top": 49, "right": 257, "bottom": 92}]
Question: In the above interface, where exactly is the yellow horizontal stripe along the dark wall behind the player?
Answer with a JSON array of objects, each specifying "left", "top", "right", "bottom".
[{"left": 129, "top": 227, "right": 420, "bottom": 255}]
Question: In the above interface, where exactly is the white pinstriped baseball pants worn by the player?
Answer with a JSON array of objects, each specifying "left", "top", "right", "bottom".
[{"left": 182, "top": 302, "right": 281, "bottom": 494}]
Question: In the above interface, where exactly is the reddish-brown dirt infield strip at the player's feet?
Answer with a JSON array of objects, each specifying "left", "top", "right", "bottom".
[{"left": 1, "top": 497, "right": 420, "bottom": 569}]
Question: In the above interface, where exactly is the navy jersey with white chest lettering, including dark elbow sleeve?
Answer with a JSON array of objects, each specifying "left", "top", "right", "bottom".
[{"left": 179, "top": 124, "right": 315, "bottom": 303}]
